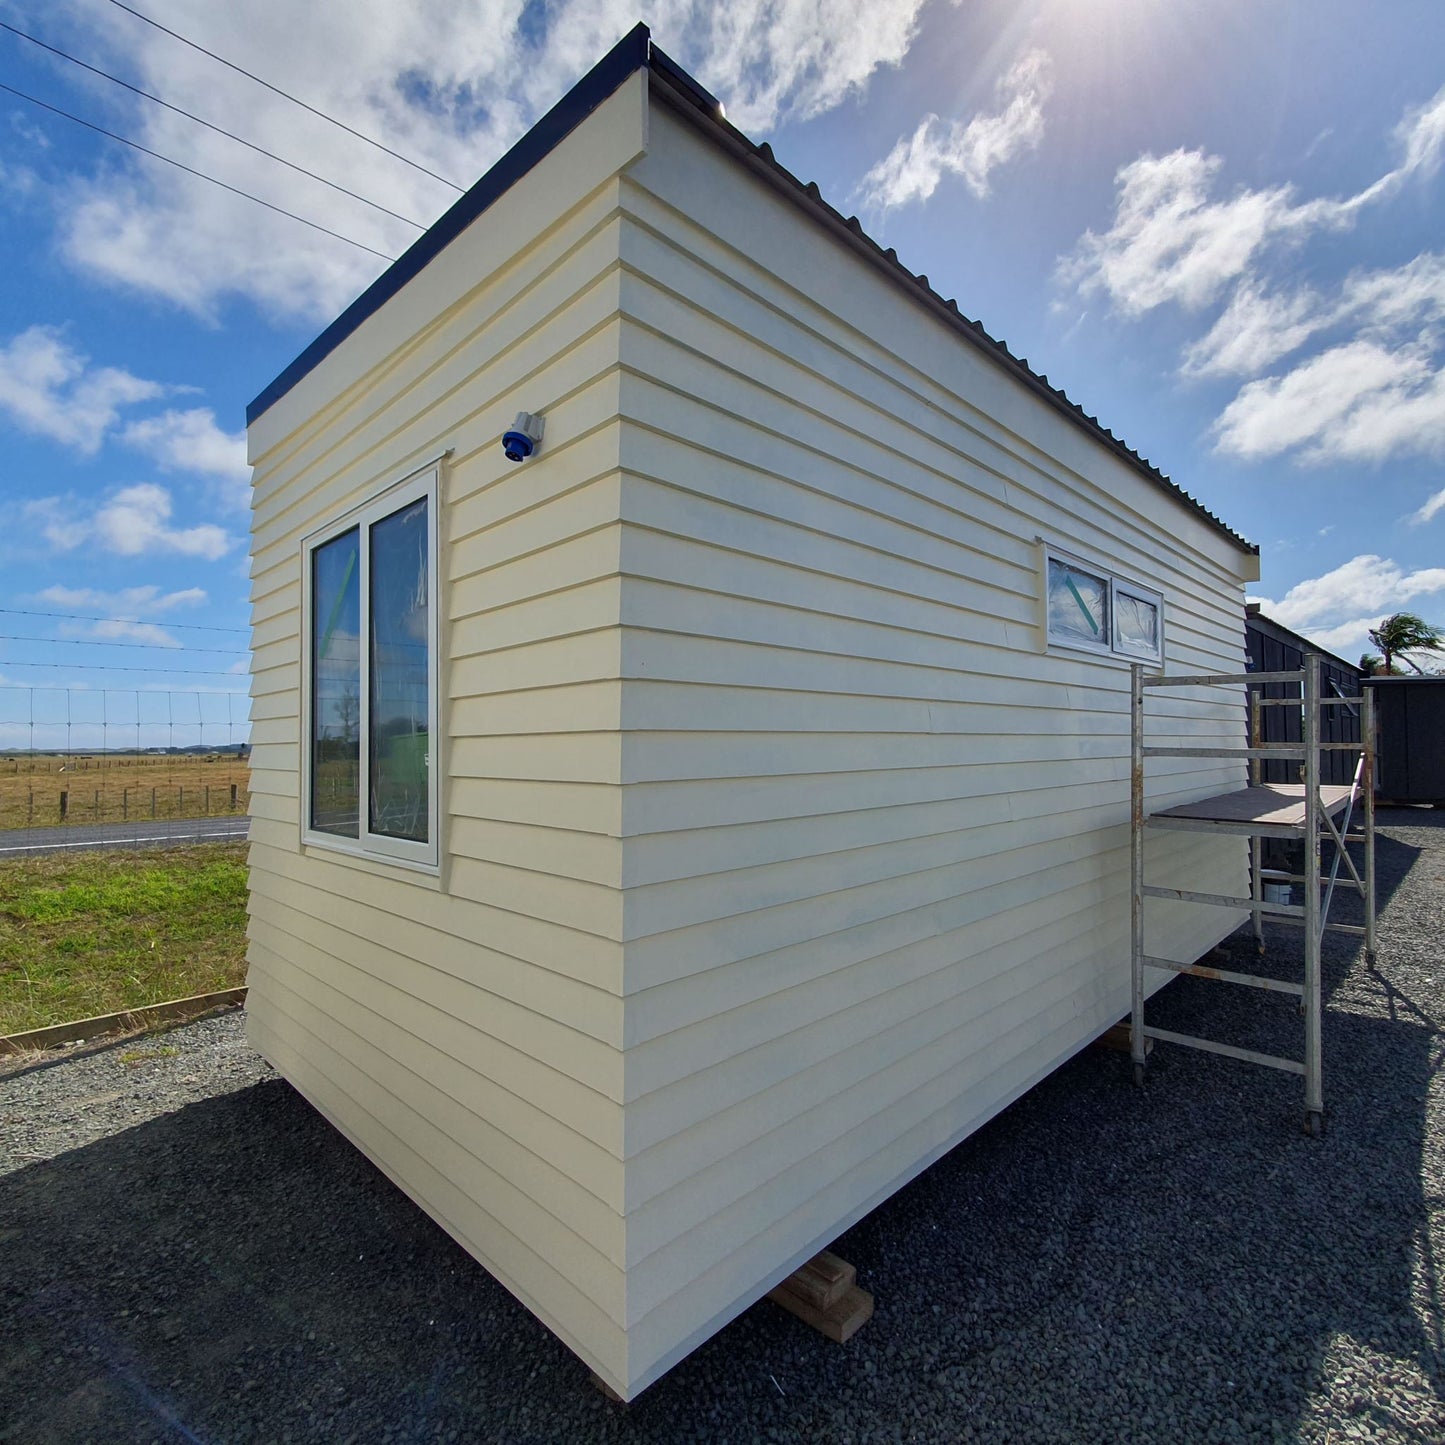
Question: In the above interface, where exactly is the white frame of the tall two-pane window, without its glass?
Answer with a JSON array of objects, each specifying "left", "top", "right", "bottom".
[{"left": 301, "top": 461, "right": 442, "bottom": 873}]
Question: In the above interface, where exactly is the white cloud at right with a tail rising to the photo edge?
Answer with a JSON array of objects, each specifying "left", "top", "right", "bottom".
[{"left": 1059, "top": 90, "right": 1445, "bottom": 322}]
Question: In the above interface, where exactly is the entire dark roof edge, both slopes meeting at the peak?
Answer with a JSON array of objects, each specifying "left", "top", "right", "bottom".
[{"left": 246, "top": 25, "right": 1259, "bottom": 555}]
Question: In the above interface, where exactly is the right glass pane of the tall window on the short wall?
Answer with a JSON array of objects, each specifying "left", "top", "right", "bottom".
[{"left": 370, "top": 497, "right": 431, "bottom": 842}]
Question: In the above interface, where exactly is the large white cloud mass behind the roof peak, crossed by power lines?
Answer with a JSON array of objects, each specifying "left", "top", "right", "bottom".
[{"left": 33, "top": 0, "right": 923, "bottom": 321}]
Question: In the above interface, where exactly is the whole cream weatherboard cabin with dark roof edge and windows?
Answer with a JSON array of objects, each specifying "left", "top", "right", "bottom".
[{"left": 249, "top": 27, "right": 1257, "bottom": 1397}]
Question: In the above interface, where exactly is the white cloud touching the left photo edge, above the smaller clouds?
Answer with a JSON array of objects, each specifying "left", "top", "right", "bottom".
[{"left": 0, "top": 327, "right": 166, "bottom": 457}]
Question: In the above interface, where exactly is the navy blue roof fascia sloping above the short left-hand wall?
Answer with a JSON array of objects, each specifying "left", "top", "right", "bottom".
[{"left": 246, "top": 25, "right": 650, "bottom": 426}]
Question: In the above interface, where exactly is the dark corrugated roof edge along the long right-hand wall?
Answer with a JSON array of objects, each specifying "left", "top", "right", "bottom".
[{"left": 650, "top": 46, "right": 1259, "bottom": 556}]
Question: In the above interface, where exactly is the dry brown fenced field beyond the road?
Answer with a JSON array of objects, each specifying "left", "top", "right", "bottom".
[{"left": 0, "top": 750, "right": 251, "bottom": 831}]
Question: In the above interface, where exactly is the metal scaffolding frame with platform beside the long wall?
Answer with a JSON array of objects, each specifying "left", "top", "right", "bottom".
[{"left": 1129, "top": 655, "right": 1377, "bottom": 1137}]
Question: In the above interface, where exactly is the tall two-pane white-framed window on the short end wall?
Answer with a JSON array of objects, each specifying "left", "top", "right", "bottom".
[{"left": 302, "top": 467, "right": 438, "bottom": 867}]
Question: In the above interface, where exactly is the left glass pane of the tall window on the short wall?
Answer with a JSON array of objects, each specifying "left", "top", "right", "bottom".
[{"left": 311, "top": 527, "right": 361, "bottom": 838}]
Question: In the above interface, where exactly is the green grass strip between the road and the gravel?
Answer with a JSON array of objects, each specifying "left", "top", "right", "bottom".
[{"left": 0, "top": 844, "right": 246, "bottom": 1033}]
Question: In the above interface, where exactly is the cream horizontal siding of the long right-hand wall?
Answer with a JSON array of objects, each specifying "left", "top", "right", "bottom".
[{"left": 618, "top": 98, "right": 1250, "bottom": 1383}]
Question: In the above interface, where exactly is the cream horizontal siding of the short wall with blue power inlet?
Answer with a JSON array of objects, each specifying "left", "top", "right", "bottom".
[{"left": 247, "top": 75, "right": 643, "bottom": 1387}]
